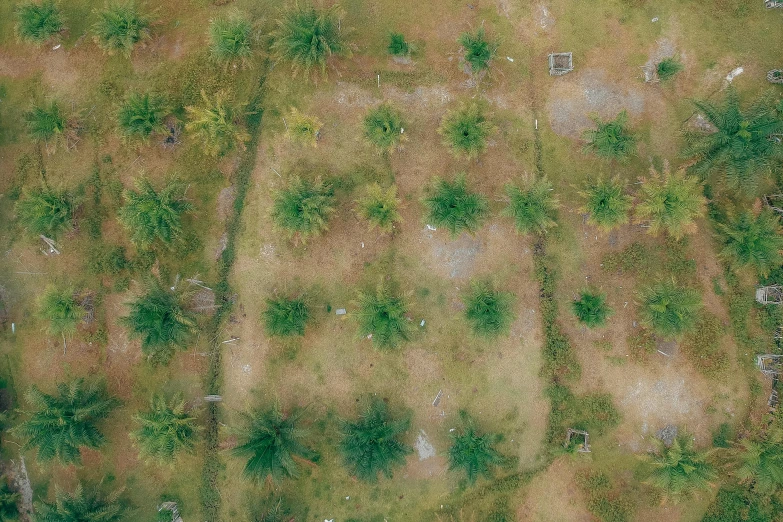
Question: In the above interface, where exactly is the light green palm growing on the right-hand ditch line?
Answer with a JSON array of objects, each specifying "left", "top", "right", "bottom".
[{"left": 503, "top": 178, "right": 560, "bottom": 234}]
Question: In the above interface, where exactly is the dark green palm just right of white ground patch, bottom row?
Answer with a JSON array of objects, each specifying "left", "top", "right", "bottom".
[{"left": 449, "top": 410, "right": 506, "bottom": 484}]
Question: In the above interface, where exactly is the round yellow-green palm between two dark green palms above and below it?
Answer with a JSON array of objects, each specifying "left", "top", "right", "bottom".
[{"left": 438, "top": 103, "right": 495, "bottom": 159}]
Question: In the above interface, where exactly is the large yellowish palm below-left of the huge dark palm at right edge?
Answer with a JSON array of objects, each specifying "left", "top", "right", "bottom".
[{"left": 636, "top": 163, "right": 706, "bottom": 240}]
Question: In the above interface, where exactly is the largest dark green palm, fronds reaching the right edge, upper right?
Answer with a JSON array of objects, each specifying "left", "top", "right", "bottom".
[{"left": 683, "top": 88, "right": 783, "bottom": 194}]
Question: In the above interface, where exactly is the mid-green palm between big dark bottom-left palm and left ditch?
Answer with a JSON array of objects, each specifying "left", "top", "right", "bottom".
[{"left": 130, "top": 395, "right": 198, "bottom": 463}]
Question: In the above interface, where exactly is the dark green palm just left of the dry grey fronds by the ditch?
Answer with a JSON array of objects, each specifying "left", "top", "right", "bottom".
[{"left": 121, "top": 281, "right": 196, "bottom": 364}]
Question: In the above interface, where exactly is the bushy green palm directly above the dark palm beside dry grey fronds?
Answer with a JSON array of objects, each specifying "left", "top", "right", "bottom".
[{"left": 119, "top": 178, "right": 193, "bottom": 250}]
